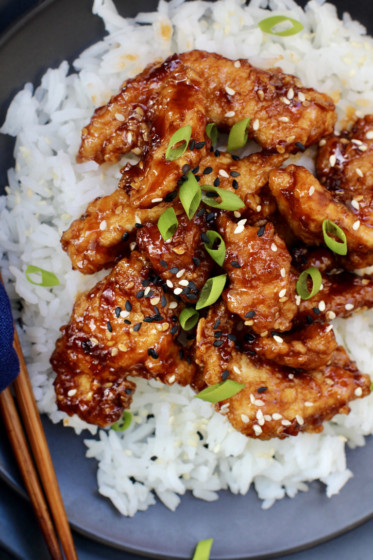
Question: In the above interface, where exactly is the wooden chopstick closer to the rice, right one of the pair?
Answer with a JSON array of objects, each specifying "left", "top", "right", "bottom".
[{"left": 0, "top": 274, "right": 78, "bottom": 560}]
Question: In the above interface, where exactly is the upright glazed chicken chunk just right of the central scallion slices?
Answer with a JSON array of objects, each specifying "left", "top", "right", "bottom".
[{"left": 218, "top": 216, "right": 297, "bottom": 334}]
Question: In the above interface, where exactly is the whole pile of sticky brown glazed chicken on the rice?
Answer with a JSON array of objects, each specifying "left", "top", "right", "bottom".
[{"left": 51, "top": 51, "right": 373, "bottom": 440}]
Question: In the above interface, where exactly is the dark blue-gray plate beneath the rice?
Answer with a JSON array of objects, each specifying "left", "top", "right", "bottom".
[{"left": 0, "top": 0, "right": 373, "bottom": 560}]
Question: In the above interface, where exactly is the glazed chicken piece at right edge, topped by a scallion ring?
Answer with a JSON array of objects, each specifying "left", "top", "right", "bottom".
[{"left": 269, "top": 165, "right": 373, "bottom": 269}]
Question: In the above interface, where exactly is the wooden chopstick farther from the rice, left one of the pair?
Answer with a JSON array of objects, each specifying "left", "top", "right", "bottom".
[{"left": 0, "top": 388, "right": 63, "bottom": 560}]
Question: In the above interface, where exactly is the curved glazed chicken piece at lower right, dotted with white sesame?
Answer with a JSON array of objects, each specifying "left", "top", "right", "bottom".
[{"left": 196, "top": 303, "right": 370, "bottom": 440}]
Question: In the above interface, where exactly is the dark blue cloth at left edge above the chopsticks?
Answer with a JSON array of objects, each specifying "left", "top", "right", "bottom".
[{"left": 0, "top": 283, "right": 19, "bottom": 391}]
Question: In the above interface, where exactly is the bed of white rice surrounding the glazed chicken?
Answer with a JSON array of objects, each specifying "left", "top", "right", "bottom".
[{"left": 0, "top": 0, "right": 373, "bottom": 516}]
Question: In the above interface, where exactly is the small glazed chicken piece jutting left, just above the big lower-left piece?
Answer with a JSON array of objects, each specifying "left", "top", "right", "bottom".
[{"left": 61, "top": 189, "right": 169, "bottom": 274}]
